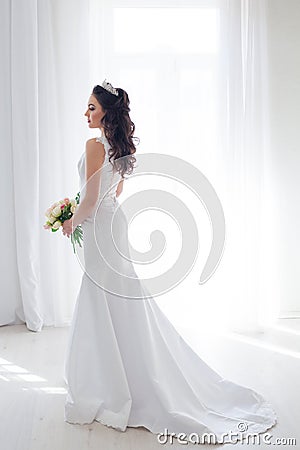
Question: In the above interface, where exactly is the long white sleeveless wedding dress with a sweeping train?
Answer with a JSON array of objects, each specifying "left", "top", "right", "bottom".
[{"left": 64, "top": 136, "right": 276, "bottom": 442}]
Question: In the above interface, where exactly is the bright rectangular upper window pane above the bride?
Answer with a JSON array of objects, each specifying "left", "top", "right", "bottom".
[{"left": 114, "top": 8, "right": 218, "bottom": 54}]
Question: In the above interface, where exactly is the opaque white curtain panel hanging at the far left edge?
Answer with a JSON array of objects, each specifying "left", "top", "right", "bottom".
[{"left": 0, "top": 1, "right": 42, "bottom": 330}]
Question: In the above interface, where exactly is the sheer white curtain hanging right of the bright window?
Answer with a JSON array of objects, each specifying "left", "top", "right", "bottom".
[{"left": 214, "top": 0, "right": 278, "bottom": 330}]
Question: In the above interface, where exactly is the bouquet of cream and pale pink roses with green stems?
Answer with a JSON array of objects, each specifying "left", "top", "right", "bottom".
[{"left": 44, "top": 192, "right": 83, "bottom": 253}]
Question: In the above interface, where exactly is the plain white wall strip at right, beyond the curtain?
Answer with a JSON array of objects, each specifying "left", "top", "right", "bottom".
[{"left": 268, "top": 0, "right": 300, "bottom": 316}]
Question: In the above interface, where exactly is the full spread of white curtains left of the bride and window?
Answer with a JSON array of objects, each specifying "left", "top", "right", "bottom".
[{"left": 0, "top": 0, "right": 90, "bottom": 331}]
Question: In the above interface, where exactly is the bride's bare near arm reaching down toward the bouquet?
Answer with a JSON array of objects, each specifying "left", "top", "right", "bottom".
[{"left": 72, "top": 139, "right": 105, "bottom": 230}]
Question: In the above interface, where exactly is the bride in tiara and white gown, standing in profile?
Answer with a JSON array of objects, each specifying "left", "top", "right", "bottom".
[{"left": 63, "top": 80, "right": 276, "bottom": 443}]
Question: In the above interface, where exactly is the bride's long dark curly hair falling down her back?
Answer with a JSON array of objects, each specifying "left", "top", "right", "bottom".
[{"left": 92, "top": 85, "right": 140, "bottom": 178}]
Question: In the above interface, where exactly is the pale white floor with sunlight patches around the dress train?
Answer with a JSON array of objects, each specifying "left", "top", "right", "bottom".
[{"left": 0, "top": 319, "right": 300, "bottom": 450}]
